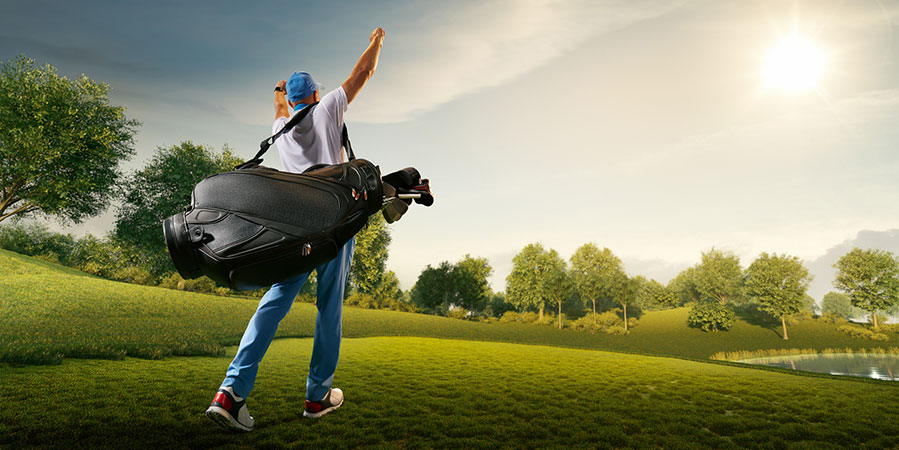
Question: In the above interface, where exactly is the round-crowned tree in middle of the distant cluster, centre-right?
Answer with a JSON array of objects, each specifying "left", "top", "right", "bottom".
[{"left": 571, "top": 243, "right": 621, "bottom": 323}]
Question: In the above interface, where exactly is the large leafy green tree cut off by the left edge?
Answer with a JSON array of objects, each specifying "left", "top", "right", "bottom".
[{"left": 0, "top": 55, "right": 139, "bottom": 223}]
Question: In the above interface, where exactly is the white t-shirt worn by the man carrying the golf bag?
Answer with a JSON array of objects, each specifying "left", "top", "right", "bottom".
[{"left": 272, "top": 86, "right": 347, "bottom": 173}]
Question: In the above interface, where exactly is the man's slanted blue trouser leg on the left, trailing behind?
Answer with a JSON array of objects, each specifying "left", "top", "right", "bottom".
[{"left": 222, "top": 273, "right": 309, "bottom": 397}]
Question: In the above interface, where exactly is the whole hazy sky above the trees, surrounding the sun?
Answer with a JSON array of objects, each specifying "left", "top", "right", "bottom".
[{"left": 0, "top": 0, "right": 899, "bottom": 290}]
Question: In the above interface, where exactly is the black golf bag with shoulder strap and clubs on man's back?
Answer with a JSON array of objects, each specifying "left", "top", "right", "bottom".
[{"left": 163, "top": 105, "right": 433, "bottom": 290}]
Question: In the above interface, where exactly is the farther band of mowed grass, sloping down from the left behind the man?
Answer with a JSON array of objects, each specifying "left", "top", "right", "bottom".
[{"left": 0, "top": 250, "right": 899, "bottom": 364}]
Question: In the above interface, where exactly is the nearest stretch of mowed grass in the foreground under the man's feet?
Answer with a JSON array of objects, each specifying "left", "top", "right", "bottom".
[{"left": 0, "top": 337, "right": 899, "bottom": 449}]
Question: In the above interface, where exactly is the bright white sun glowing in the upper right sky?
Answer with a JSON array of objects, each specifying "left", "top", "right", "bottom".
[{"left": 765, "top": 35, "right": 827, "bottom": 92}]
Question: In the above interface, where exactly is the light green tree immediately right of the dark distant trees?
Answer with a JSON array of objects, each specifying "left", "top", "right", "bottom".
[{"left": 506, "top": 243, "right": 549, "bottom": 320}]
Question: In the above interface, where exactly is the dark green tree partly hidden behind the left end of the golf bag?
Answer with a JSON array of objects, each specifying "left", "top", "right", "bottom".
[{"left": 113, "top": 141, "right": 242, "bottom": 276}]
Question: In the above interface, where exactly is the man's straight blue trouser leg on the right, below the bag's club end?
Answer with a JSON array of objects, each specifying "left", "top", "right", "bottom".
[{"left": 306, "top": 238, "right": 356, "bottom": 402}]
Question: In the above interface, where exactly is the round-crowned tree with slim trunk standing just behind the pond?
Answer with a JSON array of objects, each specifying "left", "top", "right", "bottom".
[{"left": 744, "top": 252, "right": 811, "bottom": 340}]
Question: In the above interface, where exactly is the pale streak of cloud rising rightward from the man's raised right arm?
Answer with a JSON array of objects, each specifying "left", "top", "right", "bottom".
[{"left": 353, "top": 0, "right": 684, "bottom": 123}]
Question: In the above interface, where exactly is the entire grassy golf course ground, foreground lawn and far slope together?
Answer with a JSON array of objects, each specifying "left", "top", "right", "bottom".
[{"left": 0, "top": 251, "right": 899, "bottom": 448}]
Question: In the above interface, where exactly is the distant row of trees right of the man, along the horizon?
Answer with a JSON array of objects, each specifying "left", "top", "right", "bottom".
[{"left": 411, "top": 243, "right": 899, "bottom": 339}]
